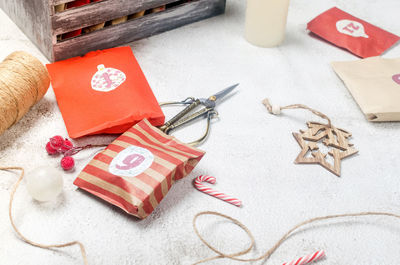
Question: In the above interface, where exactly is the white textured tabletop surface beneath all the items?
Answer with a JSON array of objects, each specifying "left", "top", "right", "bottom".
[{"left": 0, "top": 0, "right": 400, "bottom": 265}]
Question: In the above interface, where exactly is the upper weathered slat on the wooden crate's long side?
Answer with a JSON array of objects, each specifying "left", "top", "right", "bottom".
[{"left": 51, "top": 0, "right": 177, "bottom": 35}]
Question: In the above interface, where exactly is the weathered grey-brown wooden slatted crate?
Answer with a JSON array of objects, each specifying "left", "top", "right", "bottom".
[{"left": 0, "top": 0, "right": 226, "bottom": 61}]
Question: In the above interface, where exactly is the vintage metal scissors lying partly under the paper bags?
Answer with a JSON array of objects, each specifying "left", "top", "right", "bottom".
[{"left": 159, "top": 84, "right": 239, "bottom": 146}]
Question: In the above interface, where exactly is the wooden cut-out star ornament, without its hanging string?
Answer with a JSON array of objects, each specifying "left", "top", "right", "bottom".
[{"left": 293, "top": 122, "right": 358, "bottom": 177}]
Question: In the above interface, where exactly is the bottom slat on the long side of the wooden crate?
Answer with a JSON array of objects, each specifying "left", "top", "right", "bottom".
[{"left": 54, "top": 0, "right": 225, "bottom": 61}]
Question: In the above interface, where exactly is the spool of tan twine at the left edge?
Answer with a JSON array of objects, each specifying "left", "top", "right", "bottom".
[{"left": 0, "top": 51, "right": 50, "bottom": 134}]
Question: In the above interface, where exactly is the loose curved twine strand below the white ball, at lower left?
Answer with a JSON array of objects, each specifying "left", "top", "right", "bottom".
[{"left": 0, "top": 167, "right": 89, "bottom": 265}]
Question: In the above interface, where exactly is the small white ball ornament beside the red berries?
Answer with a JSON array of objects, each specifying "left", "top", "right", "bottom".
[{"left": 25, "top": 166, "right": 63, "bottom": 202}]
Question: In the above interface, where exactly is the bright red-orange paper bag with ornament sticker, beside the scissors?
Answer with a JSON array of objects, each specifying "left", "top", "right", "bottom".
[{"left": 47, "top": 47, "right": 164, "bottom": 138}]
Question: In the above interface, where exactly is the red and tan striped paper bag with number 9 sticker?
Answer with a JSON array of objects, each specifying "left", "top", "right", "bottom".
[{"left": 74, "top": 120, "right": 205, "bottom": 219}]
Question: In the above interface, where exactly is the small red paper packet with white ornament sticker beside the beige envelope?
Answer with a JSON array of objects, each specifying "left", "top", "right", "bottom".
[{"left": 307, "top": 7, "right": 400, "bottom": 58}]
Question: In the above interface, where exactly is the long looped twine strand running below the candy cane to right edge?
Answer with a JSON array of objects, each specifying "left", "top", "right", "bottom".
[{"left": 193, "top": 211, "right": 400, "bottom": 265}]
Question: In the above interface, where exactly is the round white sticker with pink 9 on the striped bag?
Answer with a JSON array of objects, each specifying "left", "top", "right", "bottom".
[{"left": 108, "top": 146, "right": 154, "bottom": 177}]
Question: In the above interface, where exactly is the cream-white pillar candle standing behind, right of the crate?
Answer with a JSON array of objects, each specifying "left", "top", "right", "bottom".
[{"left": 246, "top": 0, "right": 289, "bottom": 47}]
